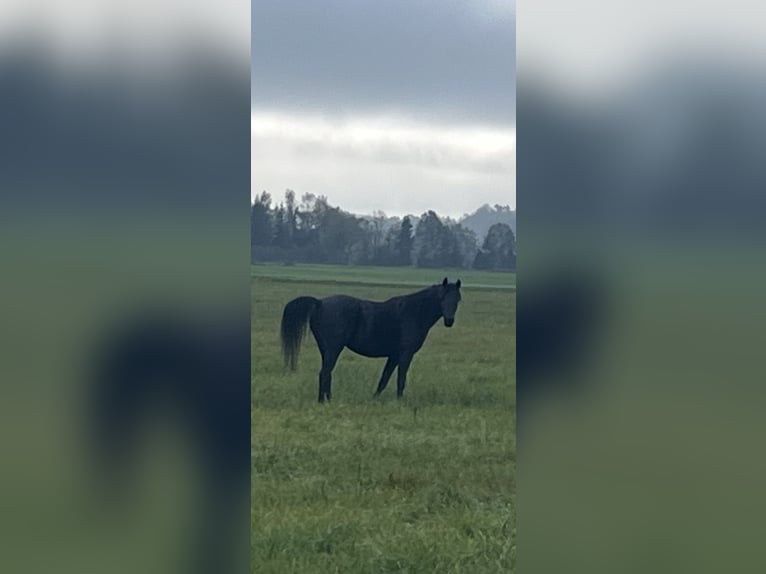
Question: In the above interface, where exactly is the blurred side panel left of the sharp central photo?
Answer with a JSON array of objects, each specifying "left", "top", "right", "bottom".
[{"left": 0, "top": 0, "right": 250, "bottom": 573}]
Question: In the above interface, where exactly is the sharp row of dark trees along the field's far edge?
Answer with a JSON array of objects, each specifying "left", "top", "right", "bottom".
[{"left": 250, "top": 189, "right": 516, "bottom": 270}]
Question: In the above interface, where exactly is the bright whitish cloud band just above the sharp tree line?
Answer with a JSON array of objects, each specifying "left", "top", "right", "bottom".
[{"left": 251, "top": 112, "right": 516, "bottom": 216}]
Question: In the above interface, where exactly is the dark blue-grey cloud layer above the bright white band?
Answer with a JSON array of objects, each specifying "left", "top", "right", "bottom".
[{"left": 252, "top": 0, "right": 516, "bottom": 125}]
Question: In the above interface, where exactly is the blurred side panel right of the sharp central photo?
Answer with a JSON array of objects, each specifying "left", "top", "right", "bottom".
[{"left": 517, "top": 1, "right": 766, "bottom": 574}]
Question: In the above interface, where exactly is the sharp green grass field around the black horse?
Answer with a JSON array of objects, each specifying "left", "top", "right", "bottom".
[{"left": 251, "top": 265, "right": 516, "bottom": 574}]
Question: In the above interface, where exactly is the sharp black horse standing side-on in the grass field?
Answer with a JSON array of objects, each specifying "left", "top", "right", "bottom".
[{"left": 282, "top": 277, "right": 460, "bottom": 403}]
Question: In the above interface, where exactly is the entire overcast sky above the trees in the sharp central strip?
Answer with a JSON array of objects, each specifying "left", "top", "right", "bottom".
[{"left": 251, "top": 0, "right": 516, "bottom": 216}]
